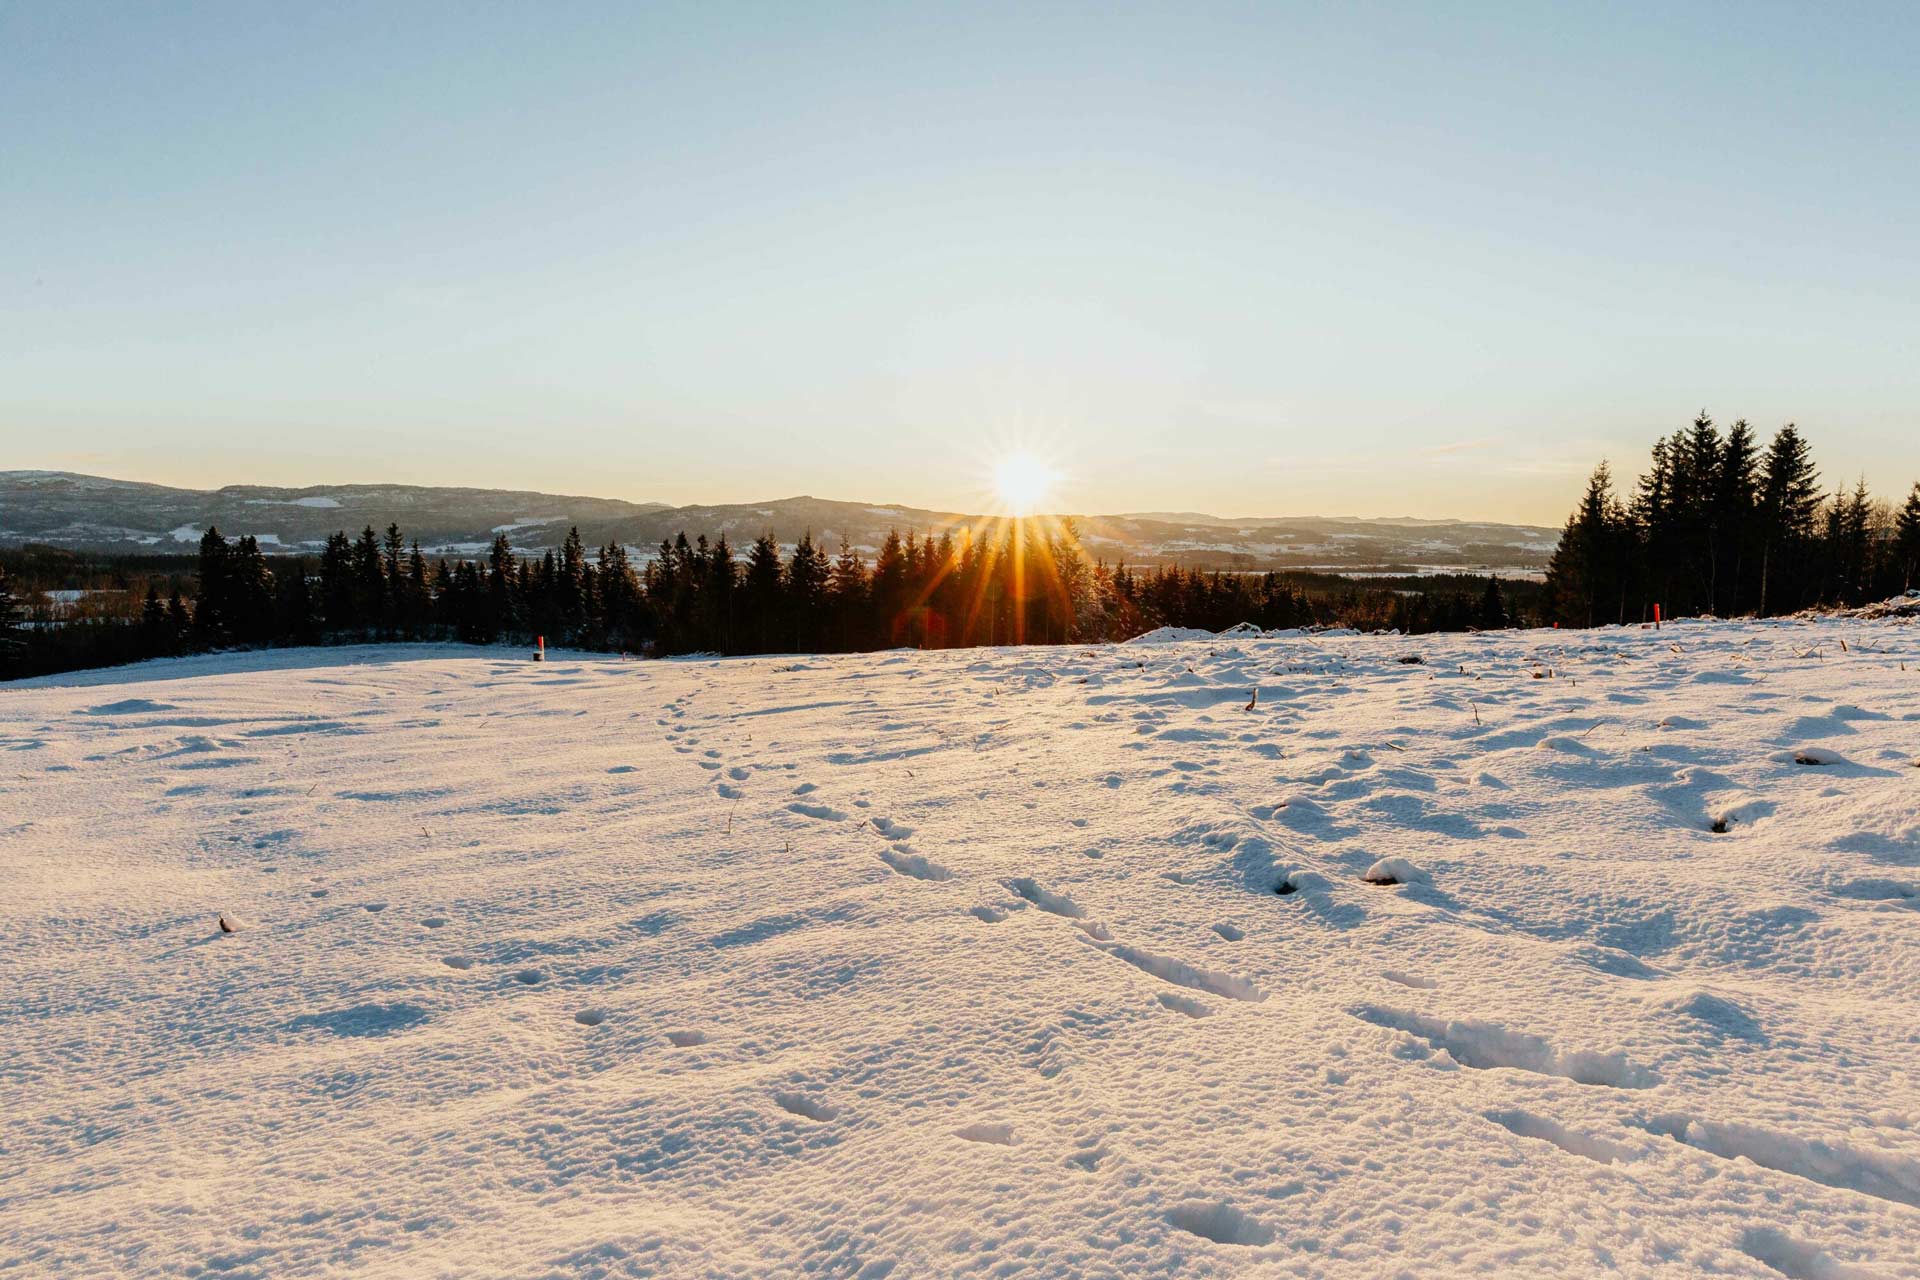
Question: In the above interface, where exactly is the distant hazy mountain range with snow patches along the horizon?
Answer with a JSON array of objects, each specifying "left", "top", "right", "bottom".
[{"left": 0, "top": 470, "right": 1559, "bottom": 572}]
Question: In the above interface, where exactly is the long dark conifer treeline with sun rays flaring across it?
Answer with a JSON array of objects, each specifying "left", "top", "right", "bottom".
[{"left": 0, "top": 520, "right": 1513, "bottom": 676}]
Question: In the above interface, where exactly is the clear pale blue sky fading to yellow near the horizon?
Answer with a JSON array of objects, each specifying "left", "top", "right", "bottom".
[{"left": 0, "top": 0, "right": 1920, "bottom": 524}]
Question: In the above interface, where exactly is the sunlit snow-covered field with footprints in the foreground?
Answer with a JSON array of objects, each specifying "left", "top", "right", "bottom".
[{"left": 0, "top": 620, "right": 1920, "bottom": 1280}]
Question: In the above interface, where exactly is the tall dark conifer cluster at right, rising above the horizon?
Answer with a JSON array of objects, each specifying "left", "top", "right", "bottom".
[{"left": 1548, "top": 413, "right": 1920, "bottom": 626}]
